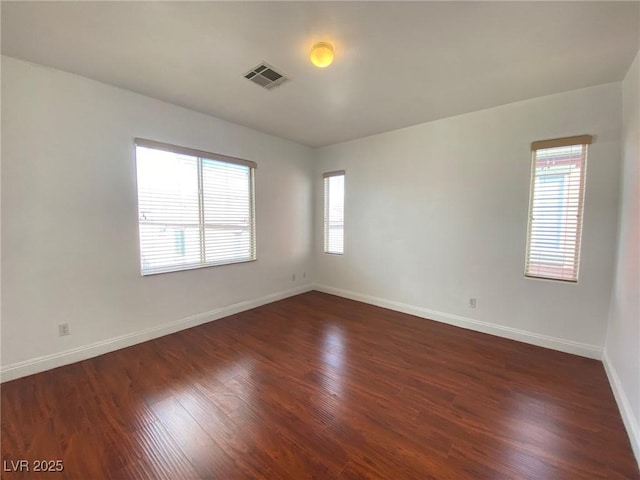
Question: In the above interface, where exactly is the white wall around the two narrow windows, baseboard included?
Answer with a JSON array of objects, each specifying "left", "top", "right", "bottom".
[{"left": 315, "top": 83, "right": 621, "bottom": 358}]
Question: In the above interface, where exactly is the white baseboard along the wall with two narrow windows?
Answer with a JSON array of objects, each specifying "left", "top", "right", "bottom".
[{"left": 315, "top": 284, "right": 602, "bottom": 360}]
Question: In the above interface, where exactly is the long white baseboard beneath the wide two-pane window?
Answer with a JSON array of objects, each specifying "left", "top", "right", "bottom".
[{"left": 0, "top": 284, "right": 313, "bottom": 382}]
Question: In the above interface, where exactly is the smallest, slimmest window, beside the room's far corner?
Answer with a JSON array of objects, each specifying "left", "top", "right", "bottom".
[{"left": 323, "top": 171, "right": 344, "bottom": 255}]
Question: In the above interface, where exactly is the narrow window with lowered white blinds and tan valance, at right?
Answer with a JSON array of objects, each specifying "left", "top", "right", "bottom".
[{"left": 525, "top": 135, "right": 591, "bottom": 282}]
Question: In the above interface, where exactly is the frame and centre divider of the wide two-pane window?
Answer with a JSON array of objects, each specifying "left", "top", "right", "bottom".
[{"left": 134, "top": 138, "right": 258, "bottom": 277}]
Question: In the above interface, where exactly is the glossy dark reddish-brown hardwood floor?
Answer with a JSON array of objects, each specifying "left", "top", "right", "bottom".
[{"left": 1, "top": 292, "right": 640, "bottom": 480}]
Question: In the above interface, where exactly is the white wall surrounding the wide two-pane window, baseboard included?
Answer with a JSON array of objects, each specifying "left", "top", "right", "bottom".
[{"left": 1, "top": 57, "right": 313, "bottom": 380}]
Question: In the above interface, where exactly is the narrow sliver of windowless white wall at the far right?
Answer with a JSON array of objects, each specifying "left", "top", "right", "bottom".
[{"left": 604, "top": 53, "right": 640, "bottom": 464}]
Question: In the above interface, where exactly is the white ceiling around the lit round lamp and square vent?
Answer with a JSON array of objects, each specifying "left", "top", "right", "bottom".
[{"left": 1, "top": 1, "right": 640, "bottom": 147}]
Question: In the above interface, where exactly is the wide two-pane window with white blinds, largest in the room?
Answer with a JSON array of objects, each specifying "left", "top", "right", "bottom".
[{"left": 135, "top": 139, "right": 256, "bottom": 275}]
